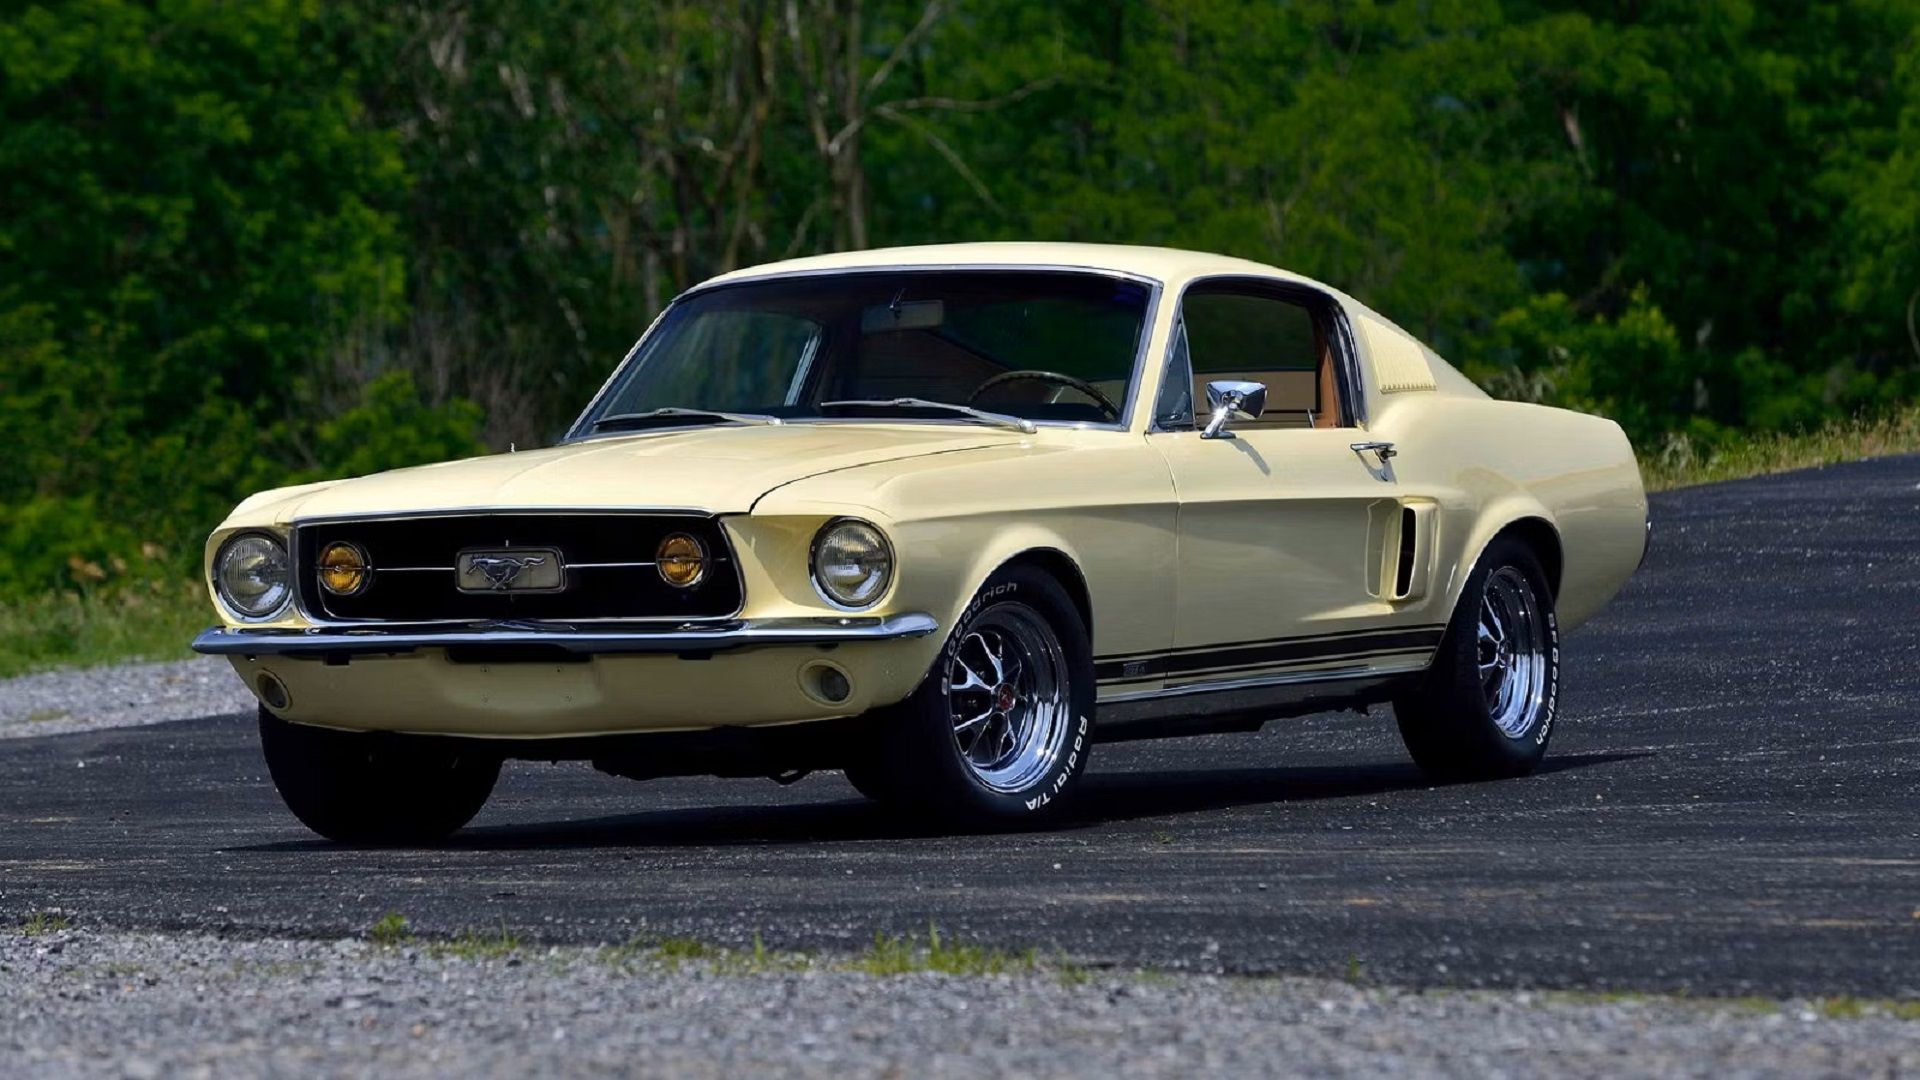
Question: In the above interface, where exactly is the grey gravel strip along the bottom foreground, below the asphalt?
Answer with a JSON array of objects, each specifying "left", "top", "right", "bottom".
[{"left": 0, "top": 928, "right": 1920, "bottom": 1078}]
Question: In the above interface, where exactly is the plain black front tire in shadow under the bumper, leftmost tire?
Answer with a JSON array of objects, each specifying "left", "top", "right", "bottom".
[{"left": 259, "top": 707, "right": 501, "bottom": 844}]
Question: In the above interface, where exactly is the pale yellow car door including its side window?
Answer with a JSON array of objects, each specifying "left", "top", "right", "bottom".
[{"left": 1150, "top": 279, "right": 1438, "bottom": 690}]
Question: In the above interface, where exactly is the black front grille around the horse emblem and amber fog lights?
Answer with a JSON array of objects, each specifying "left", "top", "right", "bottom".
[{"left": 294, "top": 513, "right": 741, "bottom": 623}]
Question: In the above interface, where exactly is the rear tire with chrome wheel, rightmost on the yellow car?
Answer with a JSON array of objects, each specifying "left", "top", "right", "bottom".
[{"left": 1394, "top": 536, "right": 1559, "bottom": 780}]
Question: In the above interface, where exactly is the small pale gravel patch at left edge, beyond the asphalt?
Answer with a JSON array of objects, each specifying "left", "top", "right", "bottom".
[{"left": 0, "top": 657, "right": 253, "bottom": 738}]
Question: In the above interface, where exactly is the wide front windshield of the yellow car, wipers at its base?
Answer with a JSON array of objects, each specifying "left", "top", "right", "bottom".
[{"left": 572, "top": 271, "right": 1152, "bottom": 438}]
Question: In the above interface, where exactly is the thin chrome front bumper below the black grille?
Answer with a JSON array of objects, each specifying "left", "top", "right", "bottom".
[{"left": 194, "top": 611, "right": 939, "bottom": 657}]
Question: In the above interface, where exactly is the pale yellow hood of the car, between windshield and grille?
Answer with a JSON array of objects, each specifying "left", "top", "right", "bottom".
[{"left": 236, "top": 423, "right": 1021, "bottom": 523}]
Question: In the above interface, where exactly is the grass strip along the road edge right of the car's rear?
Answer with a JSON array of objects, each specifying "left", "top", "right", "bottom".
[{"left": 1640, "top": 407, "right": 1920, "bottom": 492}]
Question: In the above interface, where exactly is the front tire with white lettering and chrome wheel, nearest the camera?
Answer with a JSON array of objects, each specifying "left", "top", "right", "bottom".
[{"left": 867, "top": 565, "right": 1094, "bottom": 826}]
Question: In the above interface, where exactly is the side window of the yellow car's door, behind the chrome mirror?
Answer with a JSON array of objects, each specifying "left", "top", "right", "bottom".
[{"left": 1162, "top": 282, "right": 1340, "bottom": 429}]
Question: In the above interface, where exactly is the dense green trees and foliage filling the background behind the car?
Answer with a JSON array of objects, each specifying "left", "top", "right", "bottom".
[{"left": 0, "top": 0, "right": 1920, "bottom": 598}]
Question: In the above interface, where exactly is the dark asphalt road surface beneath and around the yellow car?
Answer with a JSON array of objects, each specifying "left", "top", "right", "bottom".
[{"left": 0, "top": 457, "right": 1920, "bottom": 997}]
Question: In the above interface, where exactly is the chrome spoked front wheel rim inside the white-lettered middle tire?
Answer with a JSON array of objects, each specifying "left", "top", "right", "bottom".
[{"left": 947, "top": 603, "right": 1071, "bottom": 792}]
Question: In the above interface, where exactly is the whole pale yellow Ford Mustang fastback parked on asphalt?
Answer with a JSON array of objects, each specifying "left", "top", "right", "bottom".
[{"left": 194, "top": 244, "right": 1647, "bottom": 842}]
